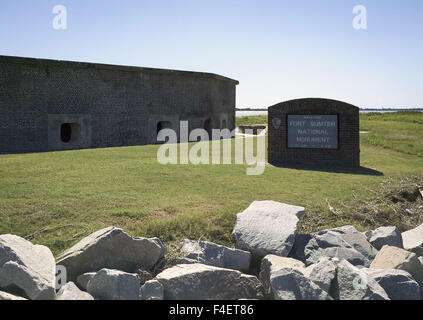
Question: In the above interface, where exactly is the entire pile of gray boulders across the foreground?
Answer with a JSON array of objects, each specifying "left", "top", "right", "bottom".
[{"left": 0, "top": 201, "right": 423, "bottom": 300}]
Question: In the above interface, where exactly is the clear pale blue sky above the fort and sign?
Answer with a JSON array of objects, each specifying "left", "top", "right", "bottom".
[{"left": 0, "top": 0, "right": 423, "bottom": 108}]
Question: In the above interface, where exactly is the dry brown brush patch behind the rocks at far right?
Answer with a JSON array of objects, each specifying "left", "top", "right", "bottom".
[{"left": 299, "top": 176, "right": 423, "bottom": 233}]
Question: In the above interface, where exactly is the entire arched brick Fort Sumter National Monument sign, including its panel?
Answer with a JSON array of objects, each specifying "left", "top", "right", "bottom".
[{"left": 268, "top": 98, "right": 360, "bottom": 168}]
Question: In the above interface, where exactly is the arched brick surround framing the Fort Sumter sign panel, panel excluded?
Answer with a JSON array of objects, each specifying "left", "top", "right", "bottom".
[{"left": 268, "top": 98, "right": 360, "bottom": 168}]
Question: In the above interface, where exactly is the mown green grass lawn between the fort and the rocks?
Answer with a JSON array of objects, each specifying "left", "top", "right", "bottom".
[{"left": 0, "top": 113, "right": 423, "bottom": 254}]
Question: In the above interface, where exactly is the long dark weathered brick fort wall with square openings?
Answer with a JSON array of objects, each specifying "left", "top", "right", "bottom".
[{"left": 0, "top": 56, "right": 238, "bottom": 153}]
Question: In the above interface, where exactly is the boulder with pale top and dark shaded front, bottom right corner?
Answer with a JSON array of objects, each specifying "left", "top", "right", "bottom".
[{"left": 364, "top": 269, "right": 420, "bottom": 300}]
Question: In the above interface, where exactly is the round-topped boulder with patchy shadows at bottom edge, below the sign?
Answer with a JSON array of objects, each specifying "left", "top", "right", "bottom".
[{"left": 270, "top": 268, "right": 332, "bottom": 300}]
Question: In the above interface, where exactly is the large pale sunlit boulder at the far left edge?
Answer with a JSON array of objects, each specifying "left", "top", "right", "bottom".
[{"left": 0, "top": 234, "right": 56, "bottom": 300}]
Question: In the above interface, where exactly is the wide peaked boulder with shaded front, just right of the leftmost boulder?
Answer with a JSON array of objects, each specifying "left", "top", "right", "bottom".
[{"left": 57, "top": 227, "right": 166, "bottom": 281}]
